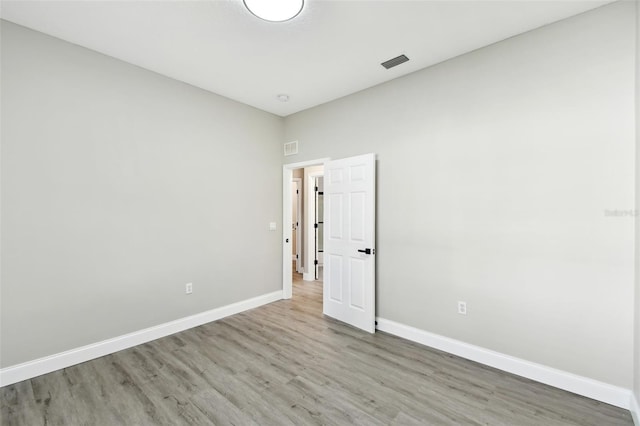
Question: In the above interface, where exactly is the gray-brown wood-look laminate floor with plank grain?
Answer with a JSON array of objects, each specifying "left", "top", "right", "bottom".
[{"left": 1, "top": 281, "right": 633, "bottom": 426}]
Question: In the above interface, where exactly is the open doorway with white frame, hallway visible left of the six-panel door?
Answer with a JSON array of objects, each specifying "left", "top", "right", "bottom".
[{"left": 282, "top": 159, "right": 327, "bottom": 299}]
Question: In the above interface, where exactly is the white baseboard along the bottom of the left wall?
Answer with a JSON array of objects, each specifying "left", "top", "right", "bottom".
[{"left": 0, "top": 290, "right": 282, "bottom": 386}]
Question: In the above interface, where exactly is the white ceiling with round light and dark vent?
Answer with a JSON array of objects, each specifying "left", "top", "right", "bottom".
[{"left": 1, "top": 0, "right": 611, "bottom": 116}]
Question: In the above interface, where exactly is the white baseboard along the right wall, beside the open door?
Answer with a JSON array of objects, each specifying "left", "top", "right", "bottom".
[{"left": 376, "top": 318, "right": 640, "bottom": 410}]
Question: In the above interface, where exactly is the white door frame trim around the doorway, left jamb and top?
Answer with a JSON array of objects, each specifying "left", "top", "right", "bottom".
[{"left": 282, "top": 158, "right": 330, "bottom": 299}]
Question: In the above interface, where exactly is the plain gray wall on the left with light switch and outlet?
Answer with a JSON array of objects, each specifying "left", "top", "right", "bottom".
[{"left": 0, "top": 21, "right": 283, "bottom": 367}]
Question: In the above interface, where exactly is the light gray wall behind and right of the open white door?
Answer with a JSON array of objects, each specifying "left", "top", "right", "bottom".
[{"left": 285, "top": 2, "right": 635, "bottom": 389}]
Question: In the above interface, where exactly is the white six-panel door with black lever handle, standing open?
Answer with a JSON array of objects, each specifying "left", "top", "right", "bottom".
[{"left": 323, "top": 154, "right": 376, "bottom": 333}]
